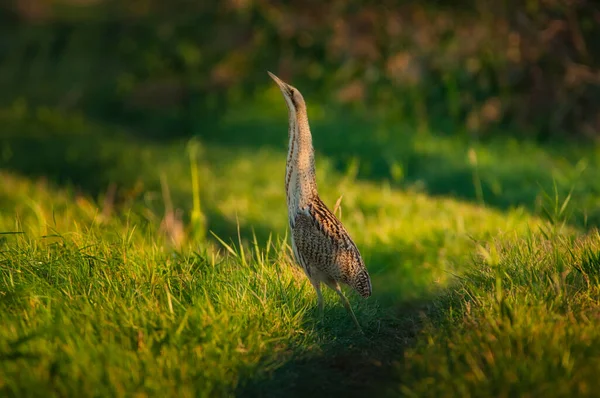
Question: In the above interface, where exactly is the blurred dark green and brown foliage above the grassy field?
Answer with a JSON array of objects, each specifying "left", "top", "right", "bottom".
[{"left": 0, "top": 0, "right": 600, "bottom": 138}]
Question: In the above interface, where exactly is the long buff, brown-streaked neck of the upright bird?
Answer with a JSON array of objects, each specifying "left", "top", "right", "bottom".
[{"left": 285, "top": 107, "right": 317, "bottom": 212}]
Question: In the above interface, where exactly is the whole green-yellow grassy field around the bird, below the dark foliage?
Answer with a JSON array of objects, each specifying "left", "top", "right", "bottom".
[{"left": 0, "top": 90, "right": 600, "bottom": 397}]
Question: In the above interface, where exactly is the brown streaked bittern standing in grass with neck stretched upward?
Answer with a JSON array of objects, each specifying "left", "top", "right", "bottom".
[{"left": 267, "top": 71, "right": 372, "bottom": 332}]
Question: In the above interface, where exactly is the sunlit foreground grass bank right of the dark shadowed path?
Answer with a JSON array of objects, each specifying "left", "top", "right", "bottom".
[{"left": 397, "top": 231, "right": 600, "bottom": 397}]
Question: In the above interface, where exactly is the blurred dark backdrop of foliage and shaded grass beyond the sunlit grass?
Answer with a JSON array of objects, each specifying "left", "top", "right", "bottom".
[{"left": 0, "top": 0, "right": 600, "bottom": 225}]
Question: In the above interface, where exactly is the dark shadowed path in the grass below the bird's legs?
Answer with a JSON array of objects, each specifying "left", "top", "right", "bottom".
[{"left": 238, "top": 288, "right": 452, "bottom": 397}]
